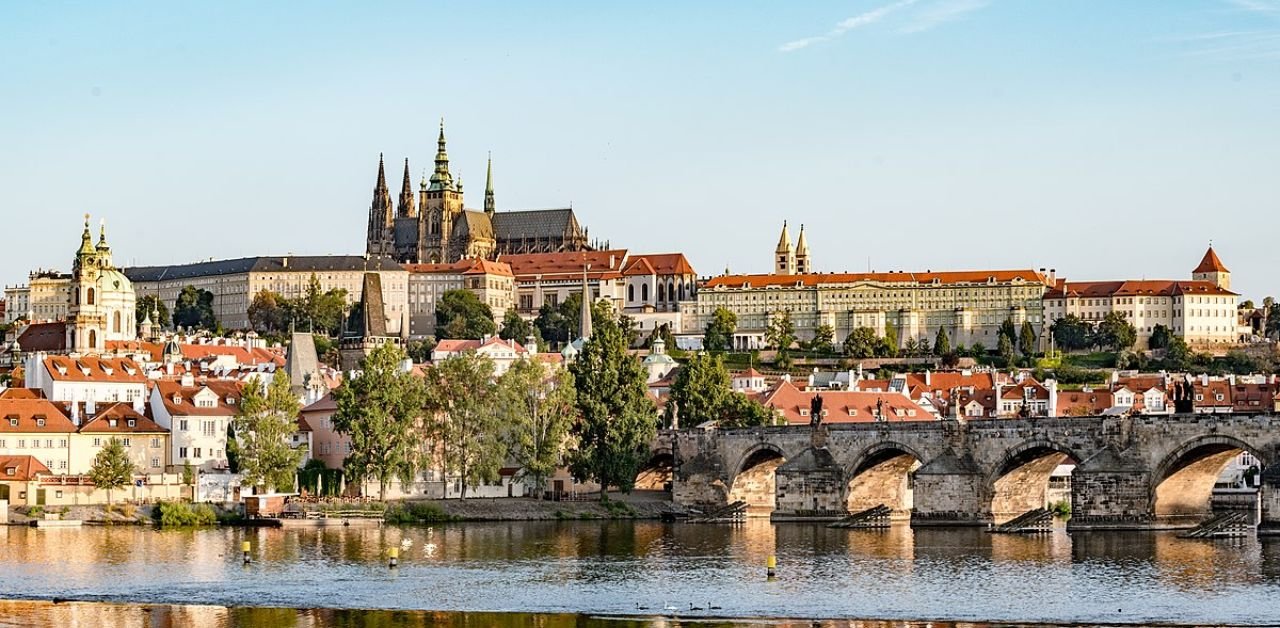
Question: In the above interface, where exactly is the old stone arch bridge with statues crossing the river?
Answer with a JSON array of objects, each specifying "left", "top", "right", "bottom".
[{"left": 655, "top": 414, "right": 1280, "bottom": 532}]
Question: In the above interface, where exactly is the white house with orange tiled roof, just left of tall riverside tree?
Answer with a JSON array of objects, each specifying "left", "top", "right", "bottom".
[{"left": 151, "top": 376, "right": 241, "bottom": 471}]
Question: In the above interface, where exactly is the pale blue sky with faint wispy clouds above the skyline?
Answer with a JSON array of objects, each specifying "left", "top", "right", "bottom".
[{"left": 0, "top": 0, "right": 1280, "bottom": 301}]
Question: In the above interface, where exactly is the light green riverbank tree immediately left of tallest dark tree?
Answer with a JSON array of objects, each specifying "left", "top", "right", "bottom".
[{"left": 498, "top": 359, "right": 577, "bottom": 496}]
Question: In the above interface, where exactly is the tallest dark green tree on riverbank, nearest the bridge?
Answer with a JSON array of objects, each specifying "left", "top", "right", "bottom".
[{"left": 570, "top": 306, "right": 658, "bottom": 500}]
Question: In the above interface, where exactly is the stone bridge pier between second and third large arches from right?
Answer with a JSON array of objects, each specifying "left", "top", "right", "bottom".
[{"left": 911, "top": 450, "right": 992, "bottom": 527}]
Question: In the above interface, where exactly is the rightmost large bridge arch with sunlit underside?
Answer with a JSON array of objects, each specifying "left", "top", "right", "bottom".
[{"left": 1151, "top": 434, "right": 1271, "bottom": 526}]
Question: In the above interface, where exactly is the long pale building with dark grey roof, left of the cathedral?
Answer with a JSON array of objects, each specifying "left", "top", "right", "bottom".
[{"left": 124, "top": 256, "right": 408, "bottom": 335}]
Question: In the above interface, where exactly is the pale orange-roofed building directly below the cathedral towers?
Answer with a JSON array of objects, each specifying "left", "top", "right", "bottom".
[{"left": 404, "top": 258, "right": 516, "bottom": 338}]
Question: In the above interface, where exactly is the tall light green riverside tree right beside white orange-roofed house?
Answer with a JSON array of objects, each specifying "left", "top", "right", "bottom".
[{"left": 234, "top": 368, "right": 303, "bottom": 492}]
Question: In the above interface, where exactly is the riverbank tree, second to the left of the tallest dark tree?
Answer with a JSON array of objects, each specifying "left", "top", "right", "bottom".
[{"left": 428, "top": 350, "right": 506, "bottom": 499}]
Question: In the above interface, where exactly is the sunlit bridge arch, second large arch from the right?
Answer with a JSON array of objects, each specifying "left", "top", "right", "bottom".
[{"left": 988, "top": 439, "right": 1080, "bottom": 524}]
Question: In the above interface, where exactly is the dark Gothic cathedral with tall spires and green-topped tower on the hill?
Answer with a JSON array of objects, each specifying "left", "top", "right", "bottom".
[{"left": 365, "top": 122, "right": 595, "bottom": 263}]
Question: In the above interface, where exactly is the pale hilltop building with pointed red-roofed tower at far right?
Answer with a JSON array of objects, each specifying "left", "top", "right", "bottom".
[{"left": 1044, "top": 247, "right": 1252, "bottom": 350}]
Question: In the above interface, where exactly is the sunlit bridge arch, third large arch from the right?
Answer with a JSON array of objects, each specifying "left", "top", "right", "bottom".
[{"left": 845, "top": 441, "right": 924, "bottom": 519}]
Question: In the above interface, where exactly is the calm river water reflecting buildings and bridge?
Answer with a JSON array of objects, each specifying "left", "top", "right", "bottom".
[{"left": 0, "top": 521, "right": 1280, "bottom": 625}]
